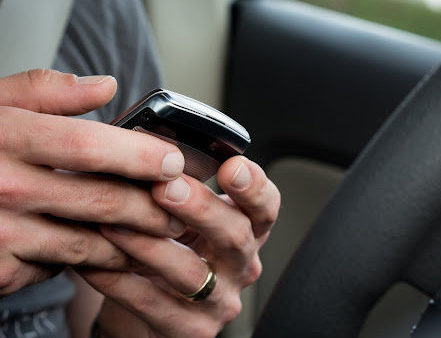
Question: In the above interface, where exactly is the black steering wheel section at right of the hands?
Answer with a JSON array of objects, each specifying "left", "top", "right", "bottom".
[{"left": 254, "top": 68, "right": 441, "bottom": 338}]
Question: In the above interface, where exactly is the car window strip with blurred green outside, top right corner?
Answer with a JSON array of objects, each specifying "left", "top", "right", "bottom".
[{"left": 300, "top": 0, "right": 441, "bottom": 40}]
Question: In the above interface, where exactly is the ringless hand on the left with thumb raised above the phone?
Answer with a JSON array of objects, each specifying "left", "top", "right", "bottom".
[{"left": 0, "top": 70, "right": 184, "bottom": 297}]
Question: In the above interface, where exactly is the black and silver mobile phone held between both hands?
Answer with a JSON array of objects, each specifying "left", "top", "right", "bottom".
[{"left": 111, "top": 89, "right": 251, "bottom": 182}]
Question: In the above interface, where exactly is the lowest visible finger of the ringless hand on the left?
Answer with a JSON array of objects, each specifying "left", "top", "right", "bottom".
[{"left": 2, "top": 213, "right": 133, "bottom": 271}]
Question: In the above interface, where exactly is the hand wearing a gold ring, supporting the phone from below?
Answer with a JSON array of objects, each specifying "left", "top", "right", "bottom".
[{"left": 81, "top": 156, "right": 280, "bottom": 338}]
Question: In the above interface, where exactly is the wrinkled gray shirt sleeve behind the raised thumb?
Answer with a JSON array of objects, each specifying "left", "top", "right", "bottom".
[{"left": 54, "top": 0, "right": 162, "bottom": 122}]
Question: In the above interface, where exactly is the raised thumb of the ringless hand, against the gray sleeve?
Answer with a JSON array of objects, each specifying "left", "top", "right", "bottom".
[{"left": 0, "top": 69, "right": 117, "bottom": 115}]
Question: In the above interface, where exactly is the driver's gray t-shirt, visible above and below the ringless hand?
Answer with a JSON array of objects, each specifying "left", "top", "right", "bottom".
[{"left": 0, "top": 0, "right": 161, "bottom": 338}]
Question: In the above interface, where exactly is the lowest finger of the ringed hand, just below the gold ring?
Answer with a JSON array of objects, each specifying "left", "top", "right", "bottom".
[{"left": 80, "top": 271, "right": 223, "bottom": 337}]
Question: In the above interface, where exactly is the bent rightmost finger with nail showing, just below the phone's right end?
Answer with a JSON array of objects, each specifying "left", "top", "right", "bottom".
[{"left": 217, "top": 156, "right": 280, "bottom": 238}]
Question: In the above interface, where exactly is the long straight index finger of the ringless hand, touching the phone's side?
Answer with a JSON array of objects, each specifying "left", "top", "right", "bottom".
[{"left": 0, "top": 108, "right": 184, "bottom": 181}]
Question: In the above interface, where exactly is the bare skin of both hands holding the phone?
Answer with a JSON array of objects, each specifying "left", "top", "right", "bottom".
[{"left": 0, "top": 70, "right": 280, "bottom": 337}]
